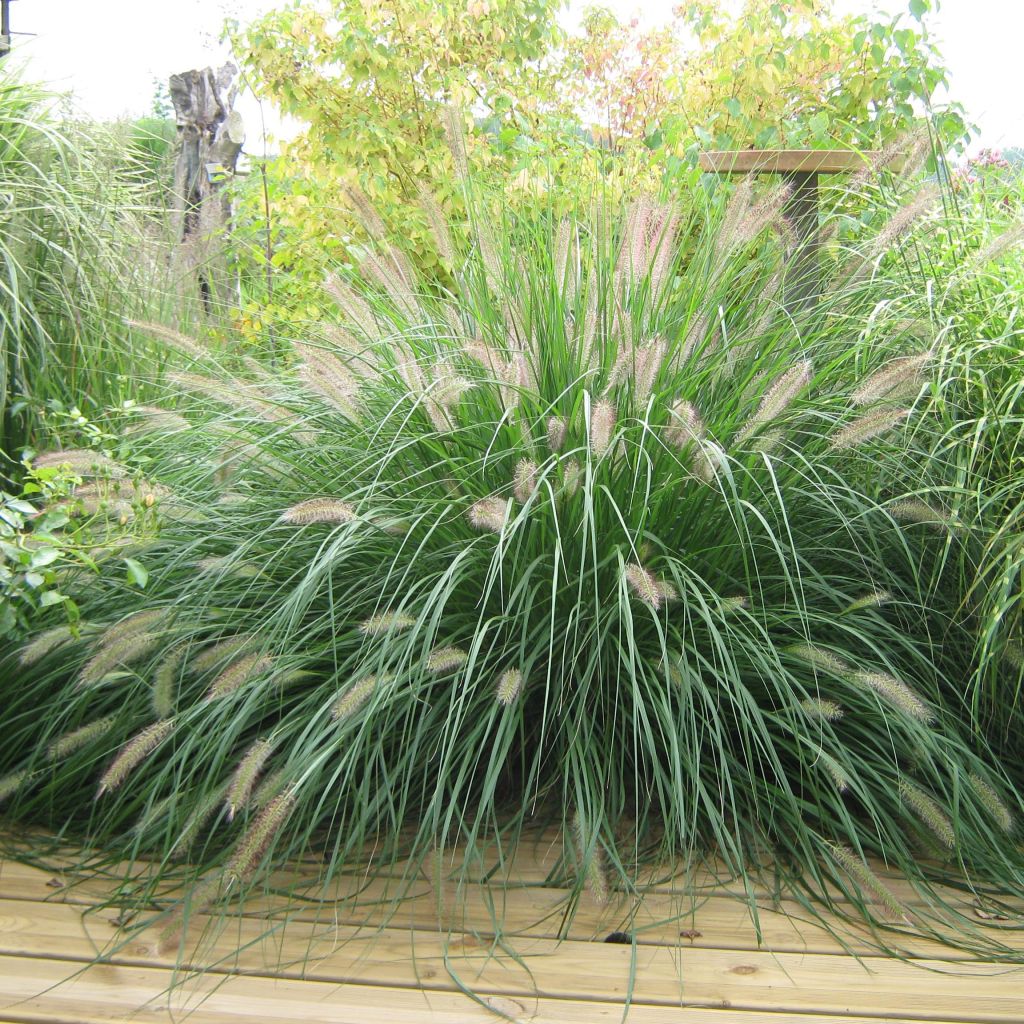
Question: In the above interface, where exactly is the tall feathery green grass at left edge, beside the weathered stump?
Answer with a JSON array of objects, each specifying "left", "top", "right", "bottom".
[{"left": 0, "top": 76, "right": 180, "bottom": 475}]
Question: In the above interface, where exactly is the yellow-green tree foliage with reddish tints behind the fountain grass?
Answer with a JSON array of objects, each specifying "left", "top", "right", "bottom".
[{"left": 230, "top": 0, "right": 963, "bottom": 331}]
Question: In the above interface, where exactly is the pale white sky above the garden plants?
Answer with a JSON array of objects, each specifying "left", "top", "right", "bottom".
[{"left": 4, "top": 0, "right": 1024, "bottom": 152}]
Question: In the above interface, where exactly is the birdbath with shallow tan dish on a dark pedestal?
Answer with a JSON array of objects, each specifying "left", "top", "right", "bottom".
[{"left": 699, "top": 150, "right": 879, "bottom": 313}]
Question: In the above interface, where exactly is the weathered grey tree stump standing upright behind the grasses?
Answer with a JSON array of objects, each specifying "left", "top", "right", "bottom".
[{"left": 170, "top": 63, "right": 245, "bottom": 313}]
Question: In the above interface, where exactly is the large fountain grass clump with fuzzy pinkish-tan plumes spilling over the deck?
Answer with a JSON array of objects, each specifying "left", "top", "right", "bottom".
[{"left": 0, "top": 180, "right": 1024, "bottom": 956}]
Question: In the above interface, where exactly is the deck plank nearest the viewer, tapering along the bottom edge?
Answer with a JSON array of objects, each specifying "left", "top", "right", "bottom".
[{"left": 0, "top": 956, "right": 991, "bottom": 1024}]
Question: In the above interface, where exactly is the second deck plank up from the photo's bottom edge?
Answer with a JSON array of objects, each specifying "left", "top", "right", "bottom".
[{"left": 0, "top": 901, "right": 1024, "bottom": 1024}]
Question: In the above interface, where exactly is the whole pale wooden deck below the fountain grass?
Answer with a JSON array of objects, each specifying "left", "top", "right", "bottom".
[{"left": 0, "top": 839, "right": 1024, "bottom": 1024}]
